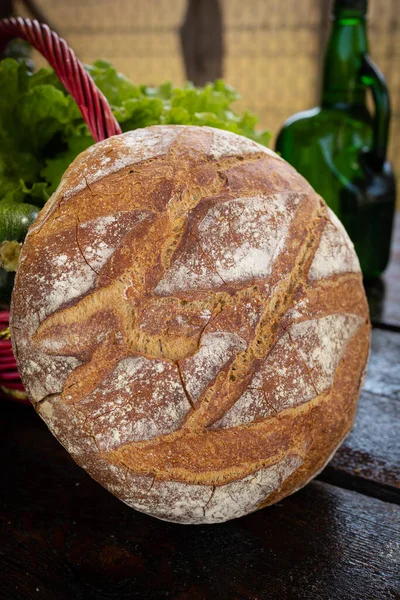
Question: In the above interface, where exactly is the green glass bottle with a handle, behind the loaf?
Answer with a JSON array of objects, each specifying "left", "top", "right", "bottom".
[{"left": 276, "top": 0, "right": 396, "bottom": 279}]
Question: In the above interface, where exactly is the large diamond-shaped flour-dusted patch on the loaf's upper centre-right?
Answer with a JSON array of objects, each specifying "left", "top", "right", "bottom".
[{"left": 155, "top": 193, "right": 301, "bottom": 294}]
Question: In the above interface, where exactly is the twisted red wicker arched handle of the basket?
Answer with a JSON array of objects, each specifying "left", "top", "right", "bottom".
[{"left": 0, "top": 17, "right": 121, "bottom": 142}]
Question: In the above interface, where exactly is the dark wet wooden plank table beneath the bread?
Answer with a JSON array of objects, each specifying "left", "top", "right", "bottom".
[{"left": 0, "top": 213, "right": 400, "bottom": 600}]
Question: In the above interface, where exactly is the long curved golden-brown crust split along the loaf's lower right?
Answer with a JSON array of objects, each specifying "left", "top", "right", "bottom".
[{"left": 108, "top": 325, "right": 369, "bottom": 488}]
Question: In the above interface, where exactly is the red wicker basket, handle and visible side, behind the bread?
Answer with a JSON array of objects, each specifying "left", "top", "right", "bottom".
[{"left": 0, "top": 18, "right": 121, "bottom": 403}]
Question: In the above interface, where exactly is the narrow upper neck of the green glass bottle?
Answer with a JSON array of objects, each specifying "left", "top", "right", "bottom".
[{"left": 321, "top": 8, "right": 368, "bottom": 108}]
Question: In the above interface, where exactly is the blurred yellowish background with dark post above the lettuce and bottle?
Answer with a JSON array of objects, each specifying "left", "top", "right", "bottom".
[{"left": 7, "top": 0, "right": 400, "bottom": 174}]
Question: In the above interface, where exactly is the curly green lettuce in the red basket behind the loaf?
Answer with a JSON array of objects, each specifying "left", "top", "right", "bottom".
[{"left": 0, "top": 58, "right": 270, "bottom": 233}]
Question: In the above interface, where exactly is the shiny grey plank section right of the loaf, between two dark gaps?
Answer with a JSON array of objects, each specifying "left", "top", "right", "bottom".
[{"left": 320, "top": 329, "right": 400, "bottom": 504}]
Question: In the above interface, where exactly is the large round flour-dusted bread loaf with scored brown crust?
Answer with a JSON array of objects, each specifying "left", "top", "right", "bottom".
[{"left": 11, "top": 125, "right": 370, "bottom": 523}]
